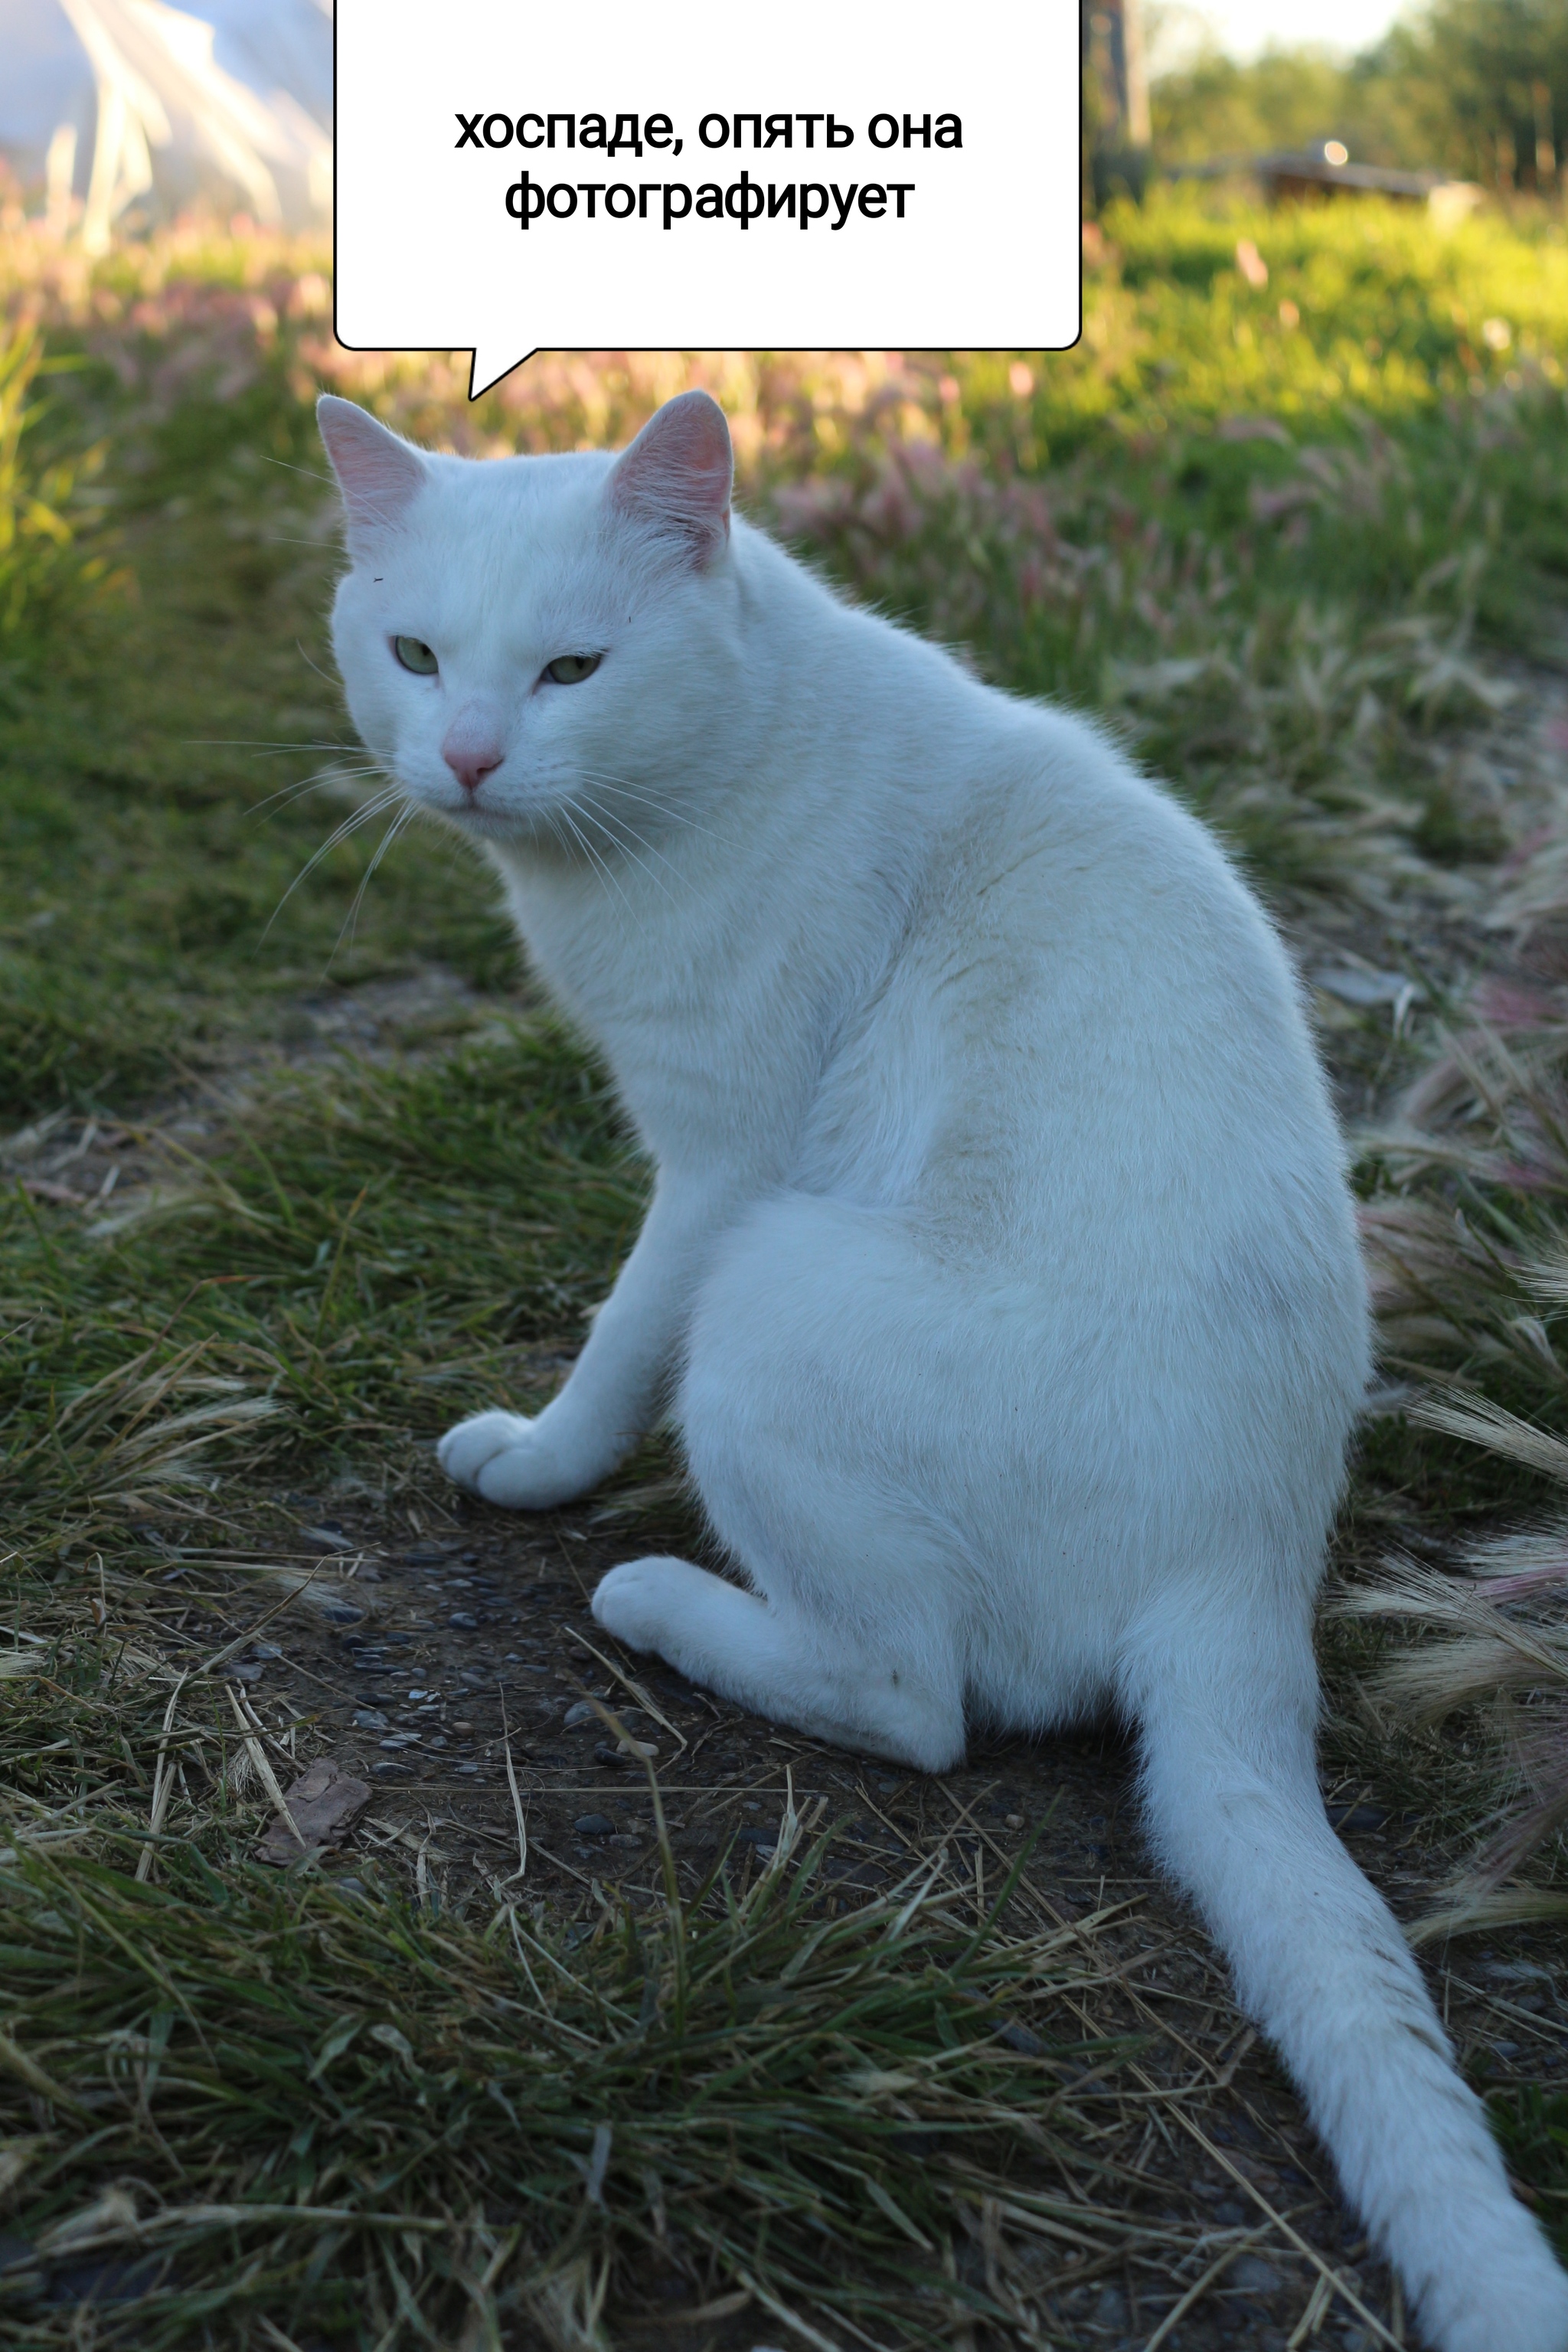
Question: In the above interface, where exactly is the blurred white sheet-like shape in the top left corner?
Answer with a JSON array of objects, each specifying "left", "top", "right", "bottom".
[{"left": 0, "top": 0, "right": 332, "bottom": 252}]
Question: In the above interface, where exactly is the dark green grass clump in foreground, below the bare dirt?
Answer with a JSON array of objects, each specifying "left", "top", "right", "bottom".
[{"left": 0, "top": 1787, "right": 1159, "bottom": 2352}]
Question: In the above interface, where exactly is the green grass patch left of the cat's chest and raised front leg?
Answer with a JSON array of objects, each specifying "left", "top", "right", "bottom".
[{"left": 0, "top": 1023, "right": 644, "bottom": 1543}]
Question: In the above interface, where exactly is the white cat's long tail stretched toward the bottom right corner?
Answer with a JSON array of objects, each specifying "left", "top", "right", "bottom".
[{"left": 1124, "top": 1604, "right": 1568, "bottom": 2352}]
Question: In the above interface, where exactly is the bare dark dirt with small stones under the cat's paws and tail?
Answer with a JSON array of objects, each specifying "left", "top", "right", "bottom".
[{"left": 144, "top": 1494, "right": 1542, "bottom": 2352}]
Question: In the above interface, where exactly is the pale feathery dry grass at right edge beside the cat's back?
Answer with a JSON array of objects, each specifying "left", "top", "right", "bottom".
[{"left": 1347, "top": 809, "right": 1568, "bottom": 1933}]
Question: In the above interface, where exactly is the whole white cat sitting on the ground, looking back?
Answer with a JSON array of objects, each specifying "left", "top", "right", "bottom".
[{"left": 320, "top": 393, "right": 1568, "bottom": 2352}]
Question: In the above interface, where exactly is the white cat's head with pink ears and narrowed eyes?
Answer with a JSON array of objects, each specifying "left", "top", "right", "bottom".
[{"left": 318, "top": 393, "right": 740, "bottom": 849}]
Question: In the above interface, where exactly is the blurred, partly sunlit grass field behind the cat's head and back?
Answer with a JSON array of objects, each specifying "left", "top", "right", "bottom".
[{"left": 0, "top": 172, "right": 1568, "bottom": 1117}]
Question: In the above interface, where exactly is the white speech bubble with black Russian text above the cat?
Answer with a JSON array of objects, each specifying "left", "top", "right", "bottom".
[{"left": 336, "top": 0, "right": 1081, "bottom": 400}]
